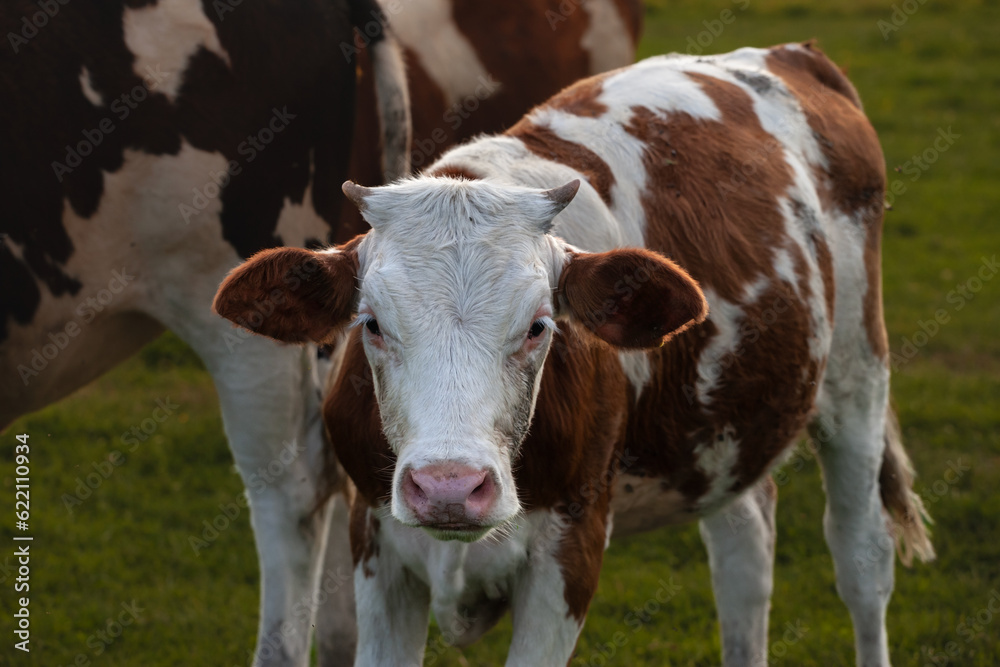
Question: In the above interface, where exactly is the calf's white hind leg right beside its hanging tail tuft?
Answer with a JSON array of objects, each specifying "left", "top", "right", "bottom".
[{"left": 812, "top": 370, "right": 895, "bottom": 667}]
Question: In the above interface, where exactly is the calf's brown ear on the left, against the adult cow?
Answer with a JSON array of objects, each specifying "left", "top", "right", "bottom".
[{"left": 212, "top": 241, "right": 358, "bottom": 343}]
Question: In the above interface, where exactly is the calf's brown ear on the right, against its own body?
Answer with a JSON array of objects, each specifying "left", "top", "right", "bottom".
[{"left": 559, "top": 248, "right": 708, "bottom": 348}]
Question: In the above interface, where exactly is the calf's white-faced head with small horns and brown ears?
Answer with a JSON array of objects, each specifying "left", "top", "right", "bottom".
[{"left": 214, "top": 177, "right": 706, "bottom": 541}]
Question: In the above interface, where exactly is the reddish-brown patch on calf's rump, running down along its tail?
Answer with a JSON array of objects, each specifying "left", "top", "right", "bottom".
[{"left": 767, "top": 44, "right": 889, "bottom": 363}]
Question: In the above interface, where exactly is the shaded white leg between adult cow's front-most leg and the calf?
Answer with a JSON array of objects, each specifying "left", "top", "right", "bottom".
[{"left": 316, "top": 494, "right": 358, "bottom": 667}]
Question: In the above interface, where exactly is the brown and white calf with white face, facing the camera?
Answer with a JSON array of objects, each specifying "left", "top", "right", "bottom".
[{"left": 215, "top": 44, "right": 933, "bottom": 665}]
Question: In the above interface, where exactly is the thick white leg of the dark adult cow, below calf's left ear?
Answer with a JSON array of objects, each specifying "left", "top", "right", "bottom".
[{"left": 157, "top": 300, "right": 329, "bottom": 666}]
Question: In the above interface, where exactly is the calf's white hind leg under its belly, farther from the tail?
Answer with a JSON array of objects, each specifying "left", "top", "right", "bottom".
[{"left": 700, "top": 477, "right": 778, "bottom": 666}]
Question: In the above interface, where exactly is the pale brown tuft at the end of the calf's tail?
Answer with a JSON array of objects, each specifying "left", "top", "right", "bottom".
[{"left": 878, "top": 408, "right": 934, "bottom": 567}]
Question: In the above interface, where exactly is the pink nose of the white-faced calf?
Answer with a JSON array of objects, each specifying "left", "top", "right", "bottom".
[{"left": 403, "top": 463, "right": 497, "bottom": 528}]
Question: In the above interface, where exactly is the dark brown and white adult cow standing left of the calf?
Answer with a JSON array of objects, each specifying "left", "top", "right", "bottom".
[{"left": 0, "top": 0, "right": 409, "bottom": 664}]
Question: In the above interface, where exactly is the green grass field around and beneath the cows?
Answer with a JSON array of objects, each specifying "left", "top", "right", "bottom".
[{"left": 0, "top": 0, "right": 1000, "bottom": 667}]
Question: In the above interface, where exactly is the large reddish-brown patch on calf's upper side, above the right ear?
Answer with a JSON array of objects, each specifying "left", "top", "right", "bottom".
[{"left": 626, "top": 74, "right": 792, "bottom": 302}]
